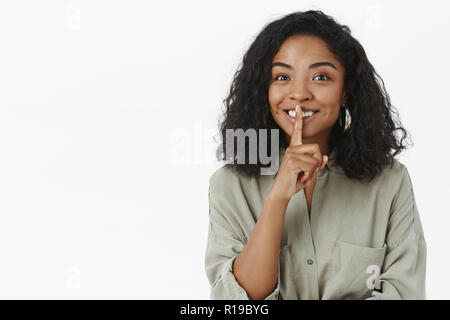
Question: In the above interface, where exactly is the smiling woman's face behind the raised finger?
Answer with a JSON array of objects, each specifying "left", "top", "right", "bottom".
[{"left": 268, "top": 35, "right": 345, "bottom": 149}]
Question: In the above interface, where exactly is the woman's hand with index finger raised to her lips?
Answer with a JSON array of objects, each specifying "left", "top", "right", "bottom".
[{"left": 270, "top": 106, "right": 328, "bottom": 201}]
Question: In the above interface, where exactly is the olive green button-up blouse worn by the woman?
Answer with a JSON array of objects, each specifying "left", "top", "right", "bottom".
[{"left": 205, "top": 150, "right": 426, "bottom": 300}]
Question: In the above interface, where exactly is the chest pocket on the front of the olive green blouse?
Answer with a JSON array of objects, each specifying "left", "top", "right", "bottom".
[{"left": 331, "top": 240, "right": 386, "bottom": 299}]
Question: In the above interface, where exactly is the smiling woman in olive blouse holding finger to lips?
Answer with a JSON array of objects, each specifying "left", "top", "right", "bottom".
[{"left": 205, "top": 11, "right": 426, "bottom": 299}]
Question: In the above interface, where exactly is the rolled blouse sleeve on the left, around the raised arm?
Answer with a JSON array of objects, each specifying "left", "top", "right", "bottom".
[{"left": 205, "top": 170, "right": 280, "bottom": 300}]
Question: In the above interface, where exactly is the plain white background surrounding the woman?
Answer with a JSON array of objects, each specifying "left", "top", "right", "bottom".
[{"left": 0, "top": 0, "right": 450, "bottom": 299}]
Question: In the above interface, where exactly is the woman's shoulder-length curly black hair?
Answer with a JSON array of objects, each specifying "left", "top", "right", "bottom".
[{"left": 217, "top": 10, "right": 409, "bottom": 181}]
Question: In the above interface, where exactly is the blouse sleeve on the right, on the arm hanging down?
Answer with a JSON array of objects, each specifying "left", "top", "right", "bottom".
[{"left": 368, "top": 166, "right": 427, "bottom": 300}]
